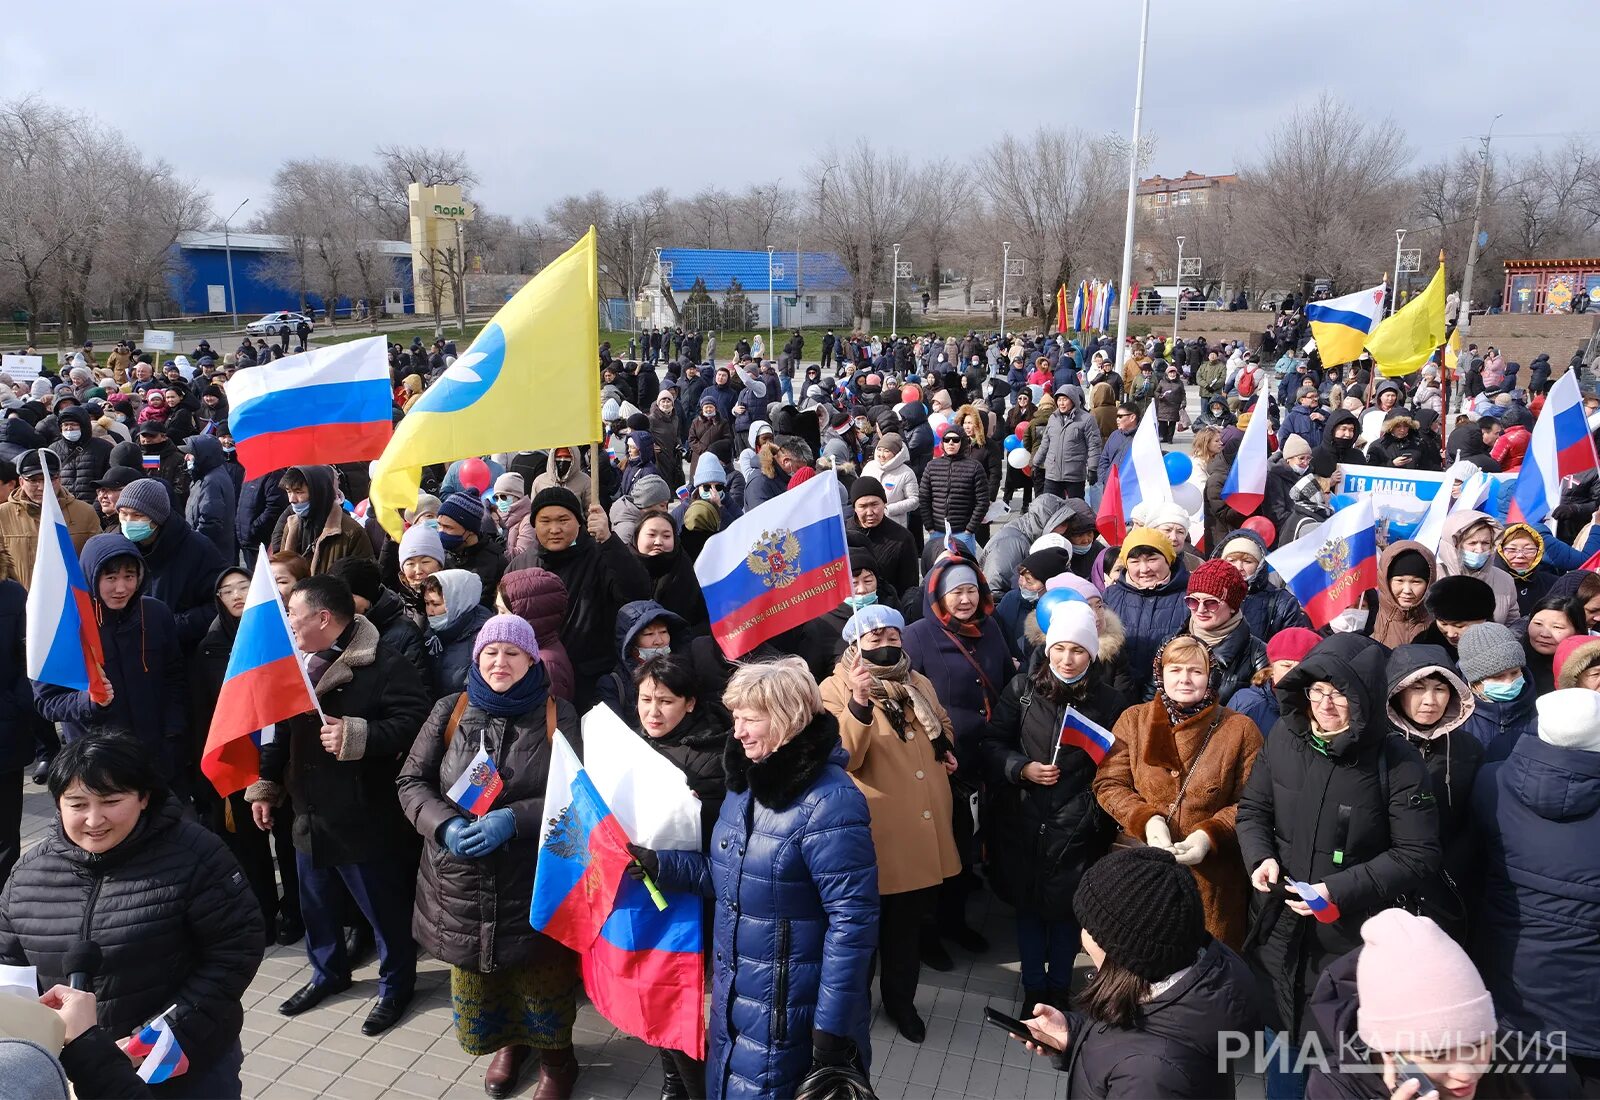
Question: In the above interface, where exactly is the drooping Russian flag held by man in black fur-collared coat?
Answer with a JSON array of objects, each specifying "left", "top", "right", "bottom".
[{"left": 200, "top": 547, "right": 318, "bottom": 798}]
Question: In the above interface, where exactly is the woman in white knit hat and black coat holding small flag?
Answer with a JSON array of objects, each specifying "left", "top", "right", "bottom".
[{"left": 982, "top": 601, "right": 1130, "bottom": 1015}]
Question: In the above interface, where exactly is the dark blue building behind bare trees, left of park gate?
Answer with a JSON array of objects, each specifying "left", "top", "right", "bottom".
[{"left": 168, "top": 232, "right": 413, "bottom": 320}]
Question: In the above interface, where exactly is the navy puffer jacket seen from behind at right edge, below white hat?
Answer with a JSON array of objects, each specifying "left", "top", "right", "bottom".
[{"left": 1472, "top": 735, "right": 1600, "bottom": 1058}]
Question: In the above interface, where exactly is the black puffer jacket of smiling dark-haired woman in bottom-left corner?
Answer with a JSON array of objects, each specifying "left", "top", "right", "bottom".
[{"left": 0, "top": 799, "right": 264, "bottom": 1066}]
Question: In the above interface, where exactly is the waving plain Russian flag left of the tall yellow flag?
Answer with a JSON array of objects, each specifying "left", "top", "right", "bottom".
[{"left": 226, "top": 336, "right": 394, "bottom": 478}]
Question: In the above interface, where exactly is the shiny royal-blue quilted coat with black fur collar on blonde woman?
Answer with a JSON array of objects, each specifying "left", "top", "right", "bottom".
[{"left": 658, "top": 713, "right": 878, "bottom": 1100}]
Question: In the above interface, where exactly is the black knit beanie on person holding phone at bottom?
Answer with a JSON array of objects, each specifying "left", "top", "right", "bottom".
[{"left": 1072, "top": 846, "right": 1211, "bottom": 982}]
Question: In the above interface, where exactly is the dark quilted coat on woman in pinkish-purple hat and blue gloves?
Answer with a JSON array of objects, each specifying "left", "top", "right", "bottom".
[{"left": 397, "top": 692, "right": 582, "bottom": 974}]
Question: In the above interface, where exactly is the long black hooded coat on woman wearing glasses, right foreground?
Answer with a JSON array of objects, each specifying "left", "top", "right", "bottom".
[{"left": 1237, "top": 635, "right": 1442, "bottom": 1038}]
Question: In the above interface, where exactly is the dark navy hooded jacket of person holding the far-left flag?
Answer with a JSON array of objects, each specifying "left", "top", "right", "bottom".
[{"left": 34, "top": 532, "right": 186, "bottom": 790}]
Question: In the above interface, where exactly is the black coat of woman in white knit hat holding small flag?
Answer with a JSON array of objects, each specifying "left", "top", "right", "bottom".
[{"left": 982, "top": 660, "right": 1128, "bottom": 921}]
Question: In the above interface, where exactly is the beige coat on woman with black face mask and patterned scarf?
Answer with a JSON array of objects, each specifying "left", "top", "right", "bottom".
[{"left": 822, "top": 662, "right": 962, "bottom": 894}]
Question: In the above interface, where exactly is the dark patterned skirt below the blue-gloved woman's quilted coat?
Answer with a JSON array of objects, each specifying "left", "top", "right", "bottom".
[{"left": 450, "top": 953, "right": 578, "bottom": 1057}]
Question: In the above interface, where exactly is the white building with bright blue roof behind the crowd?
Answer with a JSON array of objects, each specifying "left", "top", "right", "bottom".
[{"left": 642, "top": 248, "right": 851, "bottom": 329}]
